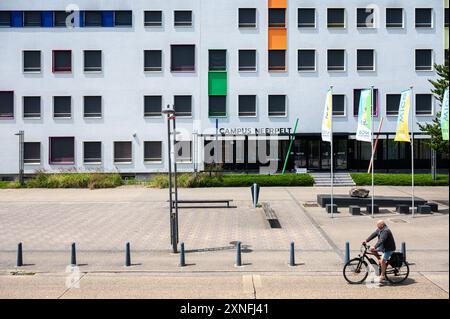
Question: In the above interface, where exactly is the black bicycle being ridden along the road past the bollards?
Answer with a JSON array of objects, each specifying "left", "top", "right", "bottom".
[{"left": 343, "top": 243, "right": 409, "bottom": 284}]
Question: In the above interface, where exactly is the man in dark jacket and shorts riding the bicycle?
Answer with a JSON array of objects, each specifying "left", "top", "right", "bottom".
[{"left": 363, "top": 219, "right": 396, "bottom": 281}]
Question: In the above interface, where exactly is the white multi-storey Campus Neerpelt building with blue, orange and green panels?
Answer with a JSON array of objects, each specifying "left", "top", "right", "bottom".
[{"left": 0, "top": 0, "right": 448, "bottom": 176}]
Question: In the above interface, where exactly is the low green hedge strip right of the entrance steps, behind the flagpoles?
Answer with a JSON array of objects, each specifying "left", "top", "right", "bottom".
[{"left": 350, "top": 173, "right": 448, "bottom": 186}]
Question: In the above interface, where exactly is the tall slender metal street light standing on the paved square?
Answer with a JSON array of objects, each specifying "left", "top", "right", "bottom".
[{"left": 161, "top": 105, "right": 178, "bottom": 253}]
